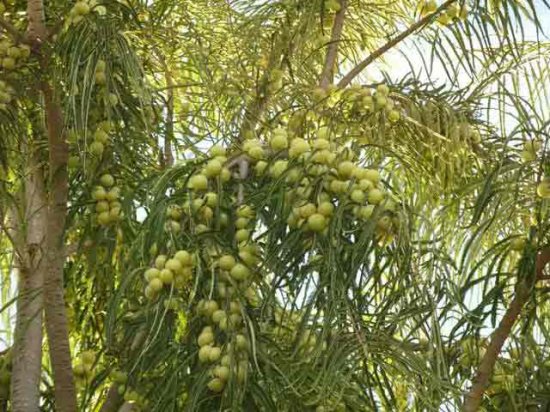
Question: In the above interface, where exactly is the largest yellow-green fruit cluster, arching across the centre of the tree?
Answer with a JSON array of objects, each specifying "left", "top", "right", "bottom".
[{"left": 243, "top": 127, "right": 399, "bottom": 243}]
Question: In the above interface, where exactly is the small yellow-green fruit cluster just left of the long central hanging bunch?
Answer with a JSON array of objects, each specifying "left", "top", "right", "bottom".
[{"left": 144, "top": 250, "right": 195, "bottom": 303}]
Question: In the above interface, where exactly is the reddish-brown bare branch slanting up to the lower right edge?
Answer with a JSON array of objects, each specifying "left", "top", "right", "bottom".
[{"left": 463, "top": 249, "right": 550, "bottom": 412}]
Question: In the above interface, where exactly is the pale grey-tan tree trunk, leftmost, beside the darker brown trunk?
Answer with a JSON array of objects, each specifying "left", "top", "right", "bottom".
[{"left": 10, "top": 152, "right": 47, "bottom": 412}]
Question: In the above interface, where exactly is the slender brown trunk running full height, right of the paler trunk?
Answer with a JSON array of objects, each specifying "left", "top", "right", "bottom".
[{"left": 27, "top": 0, "right": 77, "bottom": 412}]
